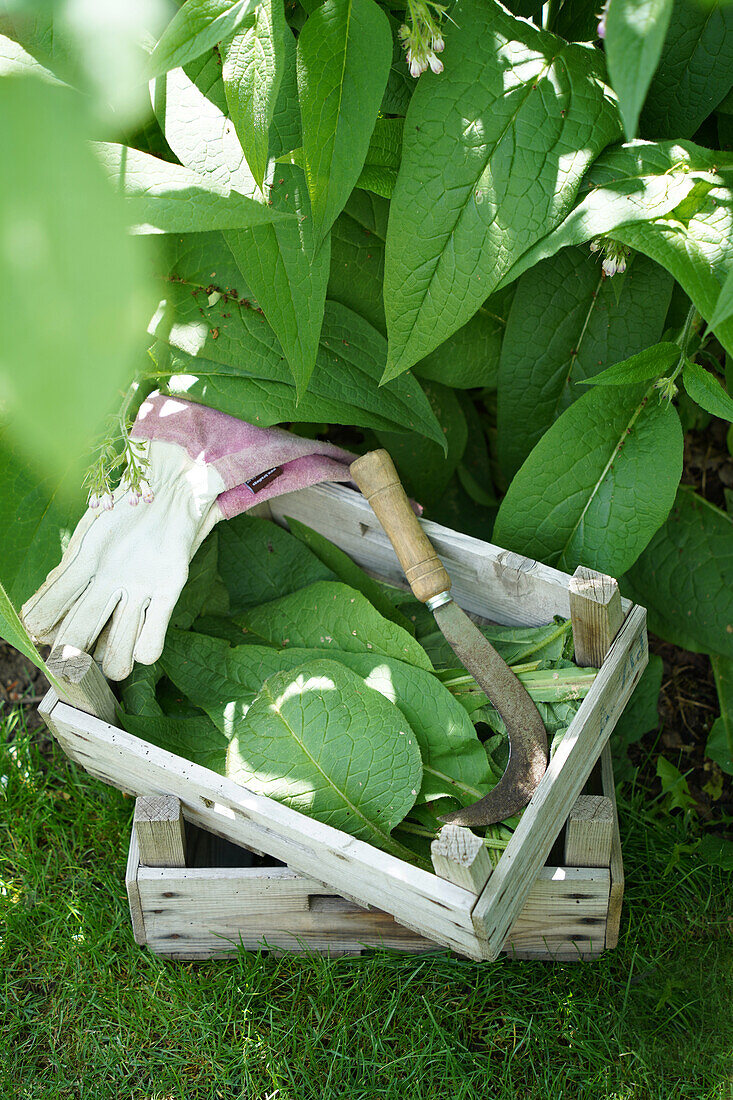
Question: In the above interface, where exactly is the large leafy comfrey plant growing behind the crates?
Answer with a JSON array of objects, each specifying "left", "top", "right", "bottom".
[{"left": 0, "top": 0, "right": 733, "bottom": 783}]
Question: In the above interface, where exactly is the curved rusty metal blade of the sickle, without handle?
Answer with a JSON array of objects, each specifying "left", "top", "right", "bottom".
[{"left": 434, "top": 600, "right": 547, "bottom": 825}]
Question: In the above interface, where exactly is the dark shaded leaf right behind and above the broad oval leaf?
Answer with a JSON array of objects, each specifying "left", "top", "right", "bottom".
[{"left": 497, "top": 249, "right": 672, "bottom": 479}]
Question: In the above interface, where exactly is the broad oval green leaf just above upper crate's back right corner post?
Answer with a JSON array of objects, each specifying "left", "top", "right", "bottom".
[{"left": 494, "top": 386, "right": 682, "bottom": 576}]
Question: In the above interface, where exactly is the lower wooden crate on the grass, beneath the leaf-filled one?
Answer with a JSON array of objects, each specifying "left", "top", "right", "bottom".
[{"left": 125, "top": 746, "right": 623, "bottom": 961}]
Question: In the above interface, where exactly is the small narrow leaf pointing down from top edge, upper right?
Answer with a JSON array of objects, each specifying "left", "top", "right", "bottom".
[{"left": 605, "top": 0, "right": 672, "bottom": 141}]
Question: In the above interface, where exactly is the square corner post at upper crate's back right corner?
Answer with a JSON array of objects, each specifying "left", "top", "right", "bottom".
[{"left": 570, "top": 565, "right": 624, "bottom": 669}]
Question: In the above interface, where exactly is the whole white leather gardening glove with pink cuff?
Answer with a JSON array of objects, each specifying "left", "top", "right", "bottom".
[{"left": 21, "top": 394, "right": 353, "bottom": 680}]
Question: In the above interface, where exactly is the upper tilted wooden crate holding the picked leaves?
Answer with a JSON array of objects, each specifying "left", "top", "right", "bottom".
[{"left": 40, "top": 486, "right": 647, "bottom": 959}]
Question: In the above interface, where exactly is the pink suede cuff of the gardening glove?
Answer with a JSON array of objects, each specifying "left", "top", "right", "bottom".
[{"left": 131, "top": 393, "right": 354, "bottom": 519}]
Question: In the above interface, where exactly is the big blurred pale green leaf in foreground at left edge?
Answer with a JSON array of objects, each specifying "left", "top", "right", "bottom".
[{"left": 0, "top": 76, "right": 151, "bottom": 484}]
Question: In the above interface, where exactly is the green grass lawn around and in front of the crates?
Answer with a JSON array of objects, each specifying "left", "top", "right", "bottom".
[{"left": 0, "top": 713, "right": 733, "bottom": 1100}]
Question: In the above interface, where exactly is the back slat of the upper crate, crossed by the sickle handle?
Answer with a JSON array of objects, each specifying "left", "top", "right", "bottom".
[{"left": 269, "top": 485, "right": 631, "bottom": 626}]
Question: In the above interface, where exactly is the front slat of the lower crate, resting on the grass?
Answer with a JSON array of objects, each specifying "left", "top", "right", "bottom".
[{"left": 131, "top": 867, "right": 610, "bottom": 959}]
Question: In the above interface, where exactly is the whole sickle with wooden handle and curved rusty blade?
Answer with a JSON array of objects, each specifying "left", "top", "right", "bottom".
[{"left": 351, "top": 451, "right": 547, "bottom": 826}]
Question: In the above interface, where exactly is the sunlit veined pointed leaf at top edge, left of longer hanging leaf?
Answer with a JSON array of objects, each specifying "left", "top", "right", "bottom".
[{"left": 221, "top": 0, "right": 291, "bottom": 189}]
